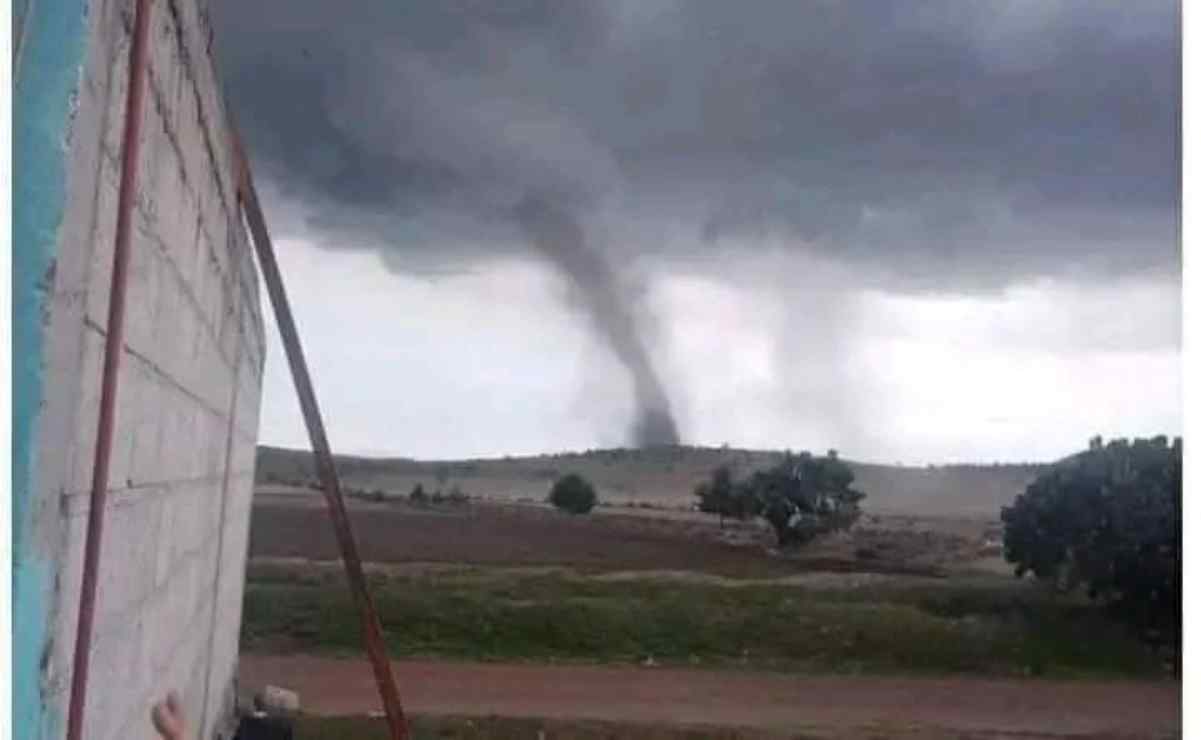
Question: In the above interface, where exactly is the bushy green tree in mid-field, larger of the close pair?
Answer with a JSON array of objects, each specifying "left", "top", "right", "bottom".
[{"left": 742, "top": 449, "right": 865, "bottom": 548}]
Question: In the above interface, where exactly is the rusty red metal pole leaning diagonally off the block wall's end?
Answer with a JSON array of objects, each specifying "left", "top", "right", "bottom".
[{"left": 231, "top": 130, "right": 408, "bottom": 740}]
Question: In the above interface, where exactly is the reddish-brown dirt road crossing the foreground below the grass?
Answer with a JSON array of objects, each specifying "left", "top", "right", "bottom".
[{"left": 240, "top": 655, "right": 1181, "bottom": 738}]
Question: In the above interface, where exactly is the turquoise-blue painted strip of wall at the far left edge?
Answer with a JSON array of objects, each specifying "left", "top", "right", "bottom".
[{"left": 12, "top": 0, "right": 88, "bottom": 740}]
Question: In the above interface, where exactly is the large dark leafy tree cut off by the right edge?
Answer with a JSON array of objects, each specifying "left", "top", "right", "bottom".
[{"left": 1000, "top": 436, "right": 1183, "bottom": 667}]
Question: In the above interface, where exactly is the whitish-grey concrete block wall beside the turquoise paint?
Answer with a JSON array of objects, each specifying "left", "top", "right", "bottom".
[{"left": 36, "top": 0, "right": 264, "bottom": 740}]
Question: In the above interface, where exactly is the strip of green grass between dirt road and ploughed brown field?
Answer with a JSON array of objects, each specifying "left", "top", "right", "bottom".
[{"left": 243, "top": 565, "right": 1161, "bottom": 678}]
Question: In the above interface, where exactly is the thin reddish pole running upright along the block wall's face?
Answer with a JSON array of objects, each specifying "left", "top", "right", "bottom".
[{"left": 67, "top": 0, "right": 151, "bottom": 740}]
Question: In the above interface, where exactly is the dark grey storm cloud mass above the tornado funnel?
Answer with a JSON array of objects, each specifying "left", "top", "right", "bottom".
[{"left": 214, "top": 0, "right": 1181, "bottom": 291}]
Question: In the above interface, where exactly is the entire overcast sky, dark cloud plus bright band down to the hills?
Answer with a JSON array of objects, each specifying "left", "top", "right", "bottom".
[{"left": 213, "top": 0, "right": 1182, "bottom": 463}]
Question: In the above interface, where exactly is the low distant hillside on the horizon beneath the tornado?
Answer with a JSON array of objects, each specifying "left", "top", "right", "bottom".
[{"left": 257, "top": 447, "right": 1042, "bottom": 517}]
